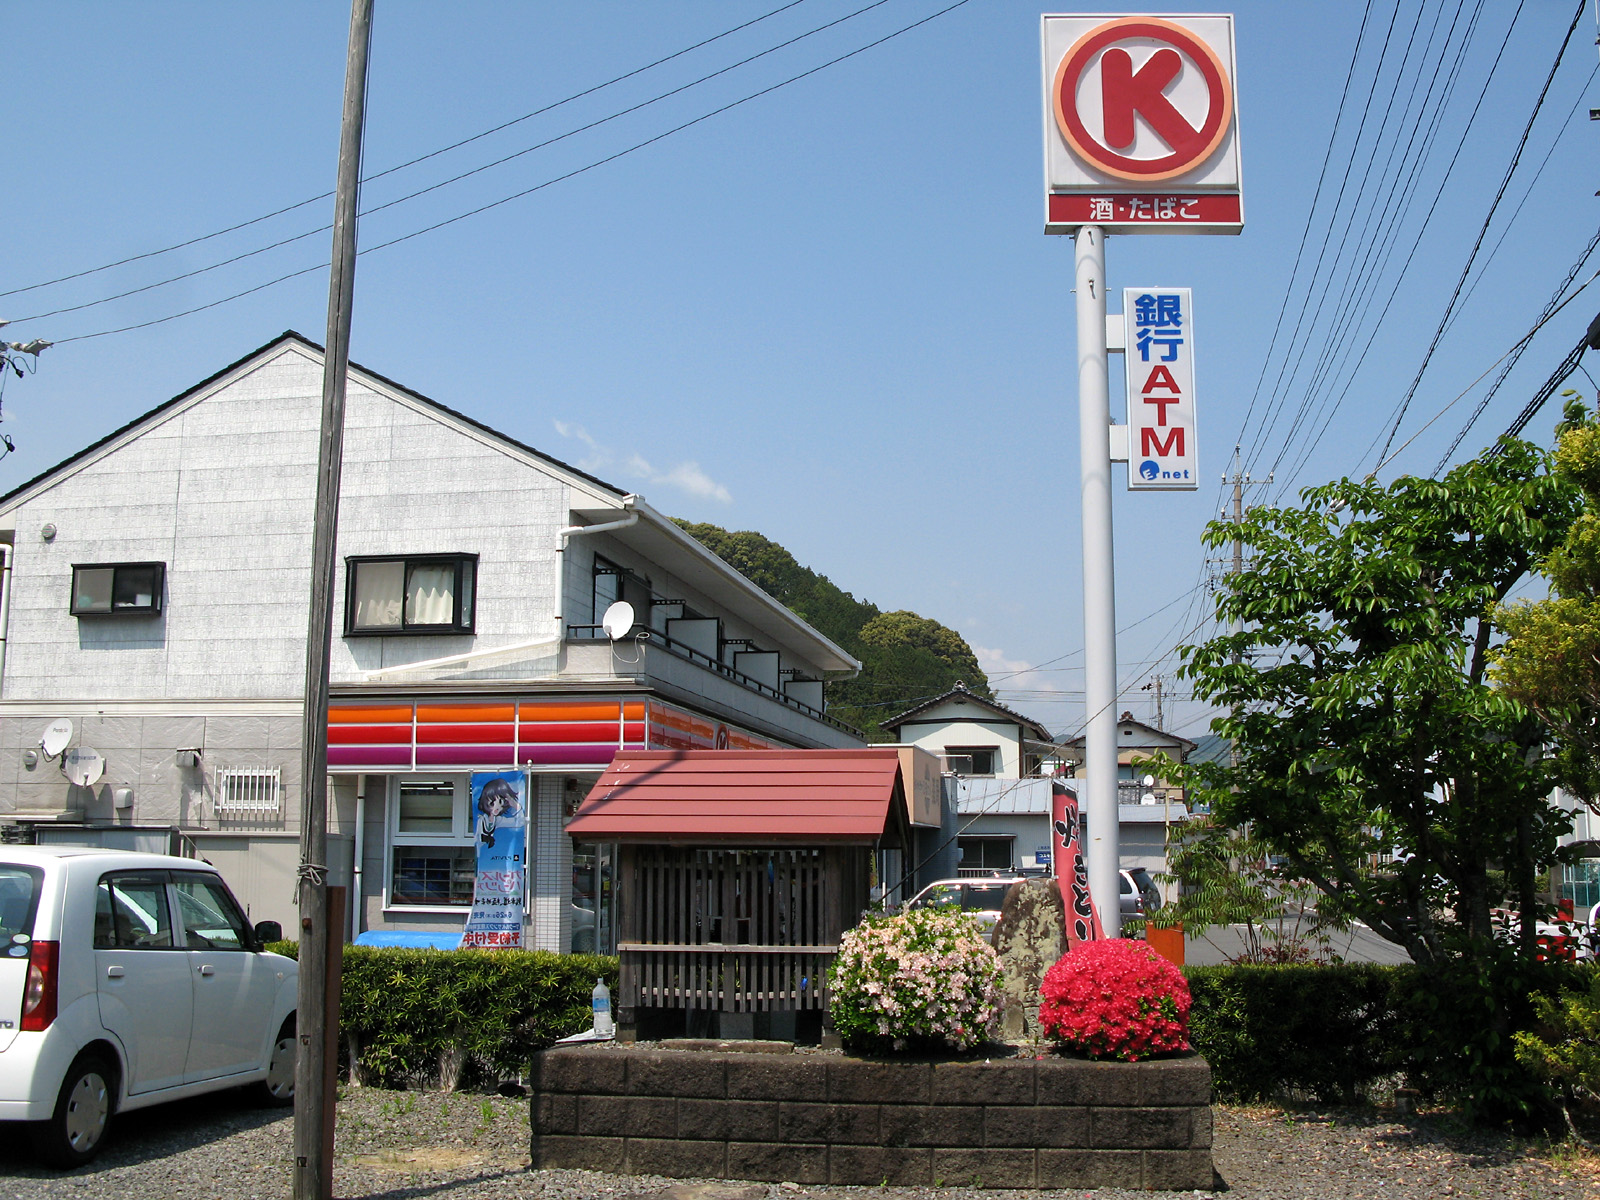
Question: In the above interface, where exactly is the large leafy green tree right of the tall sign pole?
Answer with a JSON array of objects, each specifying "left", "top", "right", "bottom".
[{"left": 1182, "top": 440, "right": 1578, "bottom": 963}]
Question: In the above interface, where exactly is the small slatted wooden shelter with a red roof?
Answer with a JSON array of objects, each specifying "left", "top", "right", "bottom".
[{"left": 568, "top": 749, "right": 909, "bottom": 1038}]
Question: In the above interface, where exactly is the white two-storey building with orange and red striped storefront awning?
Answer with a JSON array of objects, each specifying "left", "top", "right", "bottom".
[{"left": 0, "top": 333, "right": 861, "bottom": 949}]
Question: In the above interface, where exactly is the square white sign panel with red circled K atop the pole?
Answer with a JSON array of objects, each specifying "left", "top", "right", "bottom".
[{"left": 1043, "top": 14, "right": 1240, "bottom": 230}]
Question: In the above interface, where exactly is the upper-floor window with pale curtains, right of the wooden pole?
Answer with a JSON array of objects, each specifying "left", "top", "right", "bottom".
[{"left": 344, "top": 554, "right": 478, "bottom": 637}]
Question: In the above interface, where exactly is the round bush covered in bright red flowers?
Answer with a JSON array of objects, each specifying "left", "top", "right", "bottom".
[{"left": 1038, "top": 938, "right": 1189, "bottom": 1062}]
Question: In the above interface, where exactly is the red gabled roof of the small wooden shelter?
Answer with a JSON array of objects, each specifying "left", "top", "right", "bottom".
[{"left": 566, "top": 749, "right": 906, "bottom": 846}]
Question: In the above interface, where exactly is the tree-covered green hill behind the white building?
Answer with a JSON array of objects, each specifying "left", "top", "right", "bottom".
[{"left": 678, "top": 522, "right": 992, "bottom": 741}]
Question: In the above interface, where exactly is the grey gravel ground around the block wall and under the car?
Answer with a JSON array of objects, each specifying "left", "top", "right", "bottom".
[{"left": 0, "top": 1088, "right": 1600, "bottom": 1200}]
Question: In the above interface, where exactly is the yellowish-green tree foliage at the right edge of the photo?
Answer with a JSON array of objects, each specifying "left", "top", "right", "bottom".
[{"left": 1494, "top": 398, "right": 1600, "bottom": 805}]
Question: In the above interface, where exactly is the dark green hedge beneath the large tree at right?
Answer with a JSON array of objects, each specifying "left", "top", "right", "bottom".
[{"left": 1184, "top": 963, "right": 1597, "bottom": 1114}]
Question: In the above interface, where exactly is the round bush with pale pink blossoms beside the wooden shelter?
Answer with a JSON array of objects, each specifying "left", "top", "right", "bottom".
[{"left": 827, "top": 909, "right": 1000, "bottom": 1051}]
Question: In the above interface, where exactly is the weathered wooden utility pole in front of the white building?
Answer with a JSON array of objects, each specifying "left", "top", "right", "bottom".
[{"left": 294, "top": 0, "right": 373, "bottom": 1200}]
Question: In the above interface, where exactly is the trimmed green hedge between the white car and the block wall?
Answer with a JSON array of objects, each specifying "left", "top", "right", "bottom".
[{"left": 267, "top": 942, "right": 618, "bottom": 1086}]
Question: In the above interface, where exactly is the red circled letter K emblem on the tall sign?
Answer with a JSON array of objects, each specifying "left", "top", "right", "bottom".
[{"left": 1051, "top": 16, "right": 1234, "bottom": 182}]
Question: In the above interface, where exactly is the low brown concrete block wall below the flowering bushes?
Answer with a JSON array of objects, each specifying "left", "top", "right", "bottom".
[{"left": 531, "top": 1046, "right": 1214, "bottom": 1190}]
